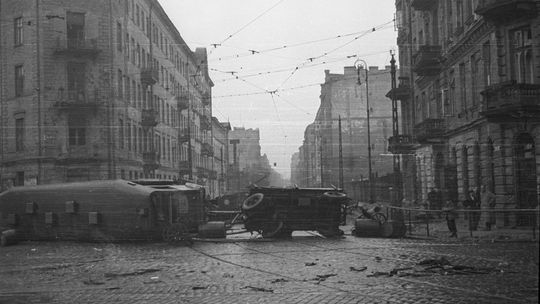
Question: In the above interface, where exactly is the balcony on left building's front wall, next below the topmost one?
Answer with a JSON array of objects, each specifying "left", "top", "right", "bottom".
[{"left": 55, "top": 90, "right": 99, "bottom": 114}]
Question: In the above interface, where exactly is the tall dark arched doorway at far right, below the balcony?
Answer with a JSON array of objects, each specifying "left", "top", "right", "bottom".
[{"left": 514, "top": 133, "right": 538, "bottom": 226}]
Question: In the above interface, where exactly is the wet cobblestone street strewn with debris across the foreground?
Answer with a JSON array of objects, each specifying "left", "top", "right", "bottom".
[{"left": 0, "top": 233, "right": 538, "bottom": 304}]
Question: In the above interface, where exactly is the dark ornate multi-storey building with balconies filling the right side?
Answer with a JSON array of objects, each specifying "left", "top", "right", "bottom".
[{"left": 389, "top": 0, "right": 540, "bottom": 226}]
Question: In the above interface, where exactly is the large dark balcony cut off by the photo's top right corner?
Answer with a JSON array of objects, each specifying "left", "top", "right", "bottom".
[{"left": 475, "top": 0, "right": 537, "bottom": 23}]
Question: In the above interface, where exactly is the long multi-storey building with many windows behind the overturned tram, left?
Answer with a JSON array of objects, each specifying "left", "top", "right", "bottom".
[{"left": 0, "top": 0, "right": 213, "bottom": 187}]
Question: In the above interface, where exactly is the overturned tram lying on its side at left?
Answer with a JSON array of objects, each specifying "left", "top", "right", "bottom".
[{"left": 0, "top": 180, "right": 206, "bottom": 242}]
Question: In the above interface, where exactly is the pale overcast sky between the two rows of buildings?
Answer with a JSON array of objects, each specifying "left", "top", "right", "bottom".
[{"left": 159, "top": 0, "right": 397, "bottom": 178}]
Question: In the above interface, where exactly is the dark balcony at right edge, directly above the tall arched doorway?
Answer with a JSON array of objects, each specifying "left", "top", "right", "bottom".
[{"left": 480, "top": 81, "right": 540, "bottom": 122}]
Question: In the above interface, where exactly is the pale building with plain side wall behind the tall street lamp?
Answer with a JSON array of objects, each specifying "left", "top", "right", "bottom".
[{"left": 292, "top": 67, "right": 392, "bottom": 201}]
